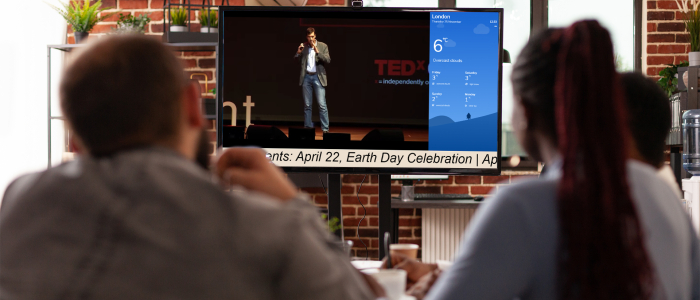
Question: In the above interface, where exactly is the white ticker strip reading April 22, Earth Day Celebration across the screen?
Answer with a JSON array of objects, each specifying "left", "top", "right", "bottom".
[{"left": 263, "top": 148, "right": 499, "bottom": 169}]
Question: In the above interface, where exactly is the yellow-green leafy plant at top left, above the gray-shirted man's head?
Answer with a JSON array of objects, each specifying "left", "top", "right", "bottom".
[{"left": 49, "top": 0, "right": 116, "bottom": 44}]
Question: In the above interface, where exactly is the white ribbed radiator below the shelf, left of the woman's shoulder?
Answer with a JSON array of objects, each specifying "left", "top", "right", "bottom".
[{"left": 421, "top": 208, "right": 476, "bottom": 263}]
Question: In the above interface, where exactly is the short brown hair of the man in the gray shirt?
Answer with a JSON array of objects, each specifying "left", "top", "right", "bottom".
[{"left": 60, "top": 35, "right": 186, "bottom": 156}]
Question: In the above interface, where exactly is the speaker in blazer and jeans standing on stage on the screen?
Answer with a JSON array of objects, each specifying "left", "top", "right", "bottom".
[{"left": 294, "top": 27, "right": 331, "bottom": 133}]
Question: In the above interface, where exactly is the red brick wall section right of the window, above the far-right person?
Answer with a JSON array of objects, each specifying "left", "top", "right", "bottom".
[{"left": 644, "top": 0, "right": 690, "bottom": 79}]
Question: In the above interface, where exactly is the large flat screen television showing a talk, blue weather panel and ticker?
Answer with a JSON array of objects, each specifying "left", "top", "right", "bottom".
[{"left": 217, "top": 7, "right": 503, "bottom": 175}]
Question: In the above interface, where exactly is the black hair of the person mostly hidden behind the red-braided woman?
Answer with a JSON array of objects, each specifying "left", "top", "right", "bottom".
[{"left": 621, "top": 73, "right": 671, "bottom": 168}]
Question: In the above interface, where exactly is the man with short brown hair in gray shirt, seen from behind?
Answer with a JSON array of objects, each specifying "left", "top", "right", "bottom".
[{"left": 0, "top": 35, "right": 374, "bottom": 299}]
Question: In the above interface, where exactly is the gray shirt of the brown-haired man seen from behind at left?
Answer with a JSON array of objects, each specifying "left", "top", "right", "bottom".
[{"left": 0, "top": 148, "right": 372, "bottom": 300}]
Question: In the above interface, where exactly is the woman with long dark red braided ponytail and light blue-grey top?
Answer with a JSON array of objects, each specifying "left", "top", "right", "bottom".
[{"left": 394, "top": 21, "right": 700, "bottom": 300}]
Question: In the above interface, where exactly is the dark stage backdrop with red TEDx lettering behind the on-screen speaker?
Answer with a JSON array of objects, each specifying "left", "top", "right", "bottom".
[{"left": 220, "top": 12, "right": 432, "bottom": 128}]
